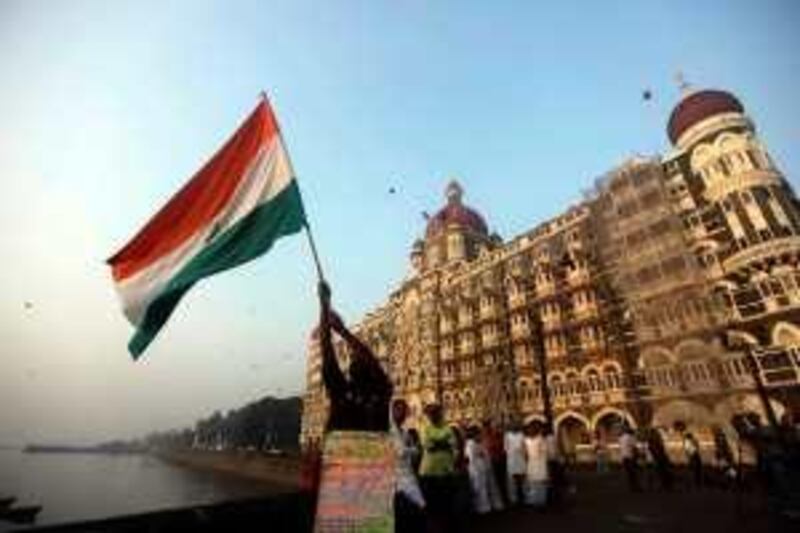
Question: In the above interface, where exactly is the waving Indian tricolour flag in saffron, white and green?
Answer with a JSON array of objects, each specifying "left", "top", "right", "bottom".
[{"left": 108, "top": 98, "right": 306, "bottom": 359}]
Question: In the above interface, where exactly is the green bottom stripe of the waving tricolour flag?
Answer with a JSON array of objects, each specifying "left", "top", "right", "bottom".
[{"left": 128, "top": 180, "right": 306, "bottom": 359}]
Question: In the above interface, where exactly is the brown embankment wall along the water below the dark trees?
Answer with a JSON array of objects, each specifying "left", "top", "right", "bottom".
[{"left": 154, "top": 450, "right": 300, "bottom": 490}]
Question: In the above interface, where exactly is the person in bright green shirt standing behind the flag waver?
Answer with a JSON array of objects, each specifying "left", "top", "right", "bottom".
[{"left": 419, "top": 404, "right": 458, "bottom": 531}]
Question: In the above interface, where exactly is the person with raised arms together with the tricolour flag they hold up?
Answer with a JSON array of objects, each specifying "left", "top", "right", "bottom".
[{"left": 108, "top": 95, "right": 395, "bottom": 533}]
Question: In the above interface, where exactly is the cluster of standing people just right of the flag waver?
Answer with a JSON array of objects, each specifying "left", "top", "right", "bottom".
[{"left": 393, "top": 399, "right": 560, "bottom": 531}]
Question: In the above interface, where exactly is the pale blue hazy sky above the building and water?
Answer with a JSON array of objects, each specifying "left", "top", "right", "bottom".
[{"left": 0, "top": 0, "right": 800, "bottom": 444}]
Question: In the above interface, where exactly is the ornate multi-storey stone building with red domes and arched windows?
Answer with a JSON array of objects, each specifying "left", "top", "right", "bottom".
[{"left": 301, "top": 85, "right": 800, "bottom": 446}]
